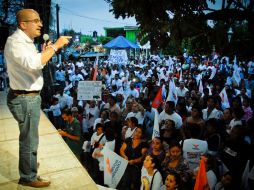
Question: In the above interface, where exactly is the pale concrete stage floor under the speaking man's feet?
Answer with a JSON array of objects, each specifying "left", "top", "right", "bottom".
[{"left": 0, "top": 91, "right": 98, "bottom": 190}]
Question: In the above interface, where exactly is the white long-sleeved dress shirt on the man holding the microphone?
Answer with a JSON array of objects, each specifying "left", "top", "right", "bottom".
[{"left": 4, "top": 29, "right": 44, "bottom": 91}]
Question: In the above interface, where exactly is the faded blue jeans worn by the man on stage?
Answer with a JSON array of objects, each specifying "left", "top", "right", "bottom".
[{"left": 7, "top": 92, "right": 41, "bottom": 182}]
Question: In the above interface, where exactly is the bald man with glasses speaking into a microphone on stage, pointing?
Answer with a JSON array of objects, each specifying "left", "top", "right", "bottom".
[{"left": 4, "top": 9, "right": 71, "bottom": 188}]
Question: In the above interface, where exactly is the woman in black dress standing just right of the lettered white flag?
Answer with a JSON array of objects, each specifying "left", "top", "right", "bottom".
[{"left": 119, "top": 127, "right": 147, "bottom": 190}]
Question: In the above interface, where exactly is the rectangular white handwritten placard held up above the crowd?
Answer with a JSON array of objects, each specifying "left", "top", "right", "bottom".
[{"left": 78, "top": 81, "right": 102, "bottom": 100}]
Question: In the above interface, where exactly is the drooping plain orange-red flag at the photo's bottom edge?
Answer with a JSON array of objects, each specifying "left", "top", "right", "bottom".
[{"left": 194, "top": 159, "right": 210, "bottom": 190}]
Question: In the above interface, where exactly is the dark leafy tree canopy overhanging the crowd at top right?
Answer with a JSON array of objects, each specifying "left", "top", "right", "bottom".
[{"left": 106, "top": 0, "right": 254, "bottom": 55}]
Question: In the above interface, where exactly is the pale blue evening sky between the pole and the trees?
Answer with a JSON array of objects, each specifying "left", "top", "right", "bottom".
[{"left": 52, "top": 0, "right": 136, "bottom": 35}]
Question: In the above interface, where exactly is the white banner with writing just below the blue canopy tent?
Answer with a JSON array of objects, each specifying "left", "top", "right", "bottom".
[{"left": 108, "top": 49, "right": 128, "bottom": 65}]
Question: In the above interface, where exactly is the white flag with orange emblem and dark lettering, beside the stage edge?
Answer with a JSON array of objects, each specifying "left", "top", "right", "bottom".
[{"left": 102, "top": 147, "right": 128, "bottom": 188}]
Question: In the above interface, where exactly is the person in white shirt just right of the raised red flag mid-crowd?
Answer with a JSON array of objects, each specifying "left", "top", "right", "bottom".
[{"left": 159, "top": 101, "right": 183, "bottom": 129}]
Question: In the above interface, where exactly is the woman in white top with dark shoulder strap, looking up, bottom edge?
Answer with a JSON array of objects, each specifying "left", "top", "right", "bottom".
[{"left": 140, "top": 154, "right": 163, "bottom": 190}]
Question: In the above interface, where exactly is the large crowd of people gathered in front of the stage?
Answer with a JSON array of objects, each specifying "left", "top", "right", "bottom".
[{"left": 39, "top": 54, "right": 254, "bottom": 190}]
